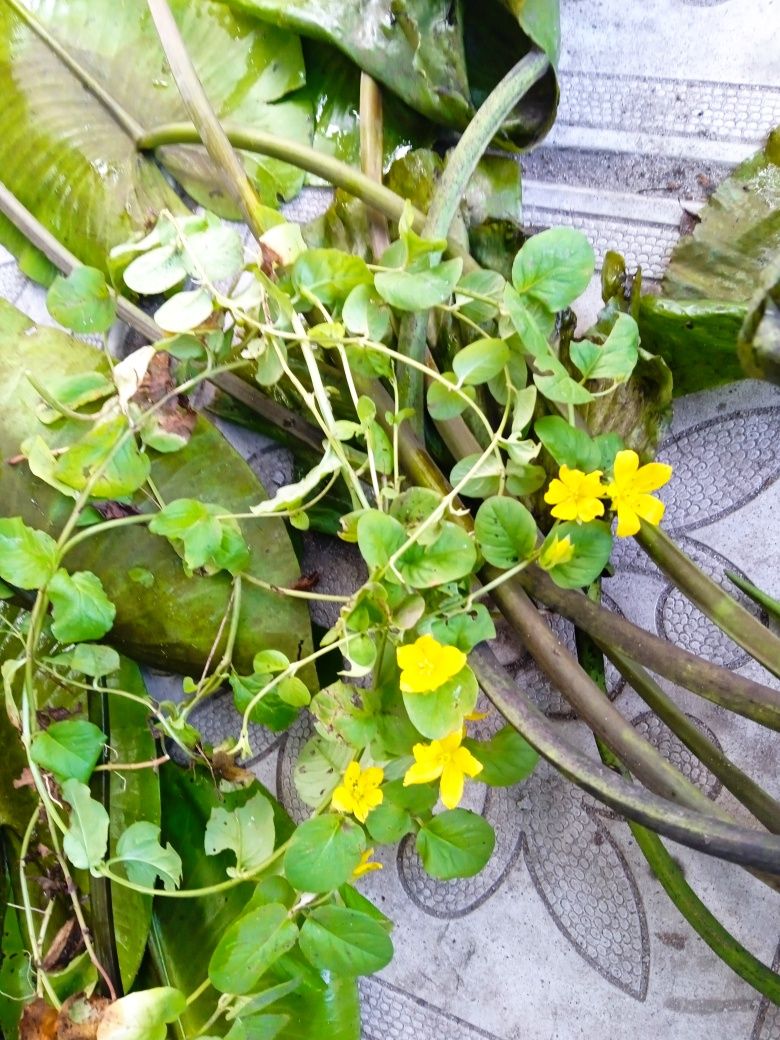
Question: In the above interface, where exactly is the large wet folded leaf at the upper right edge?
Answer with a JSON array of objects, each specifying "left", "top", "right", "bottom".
[{"left": 639, "top": 128, "right": 780, "bottom": 393}]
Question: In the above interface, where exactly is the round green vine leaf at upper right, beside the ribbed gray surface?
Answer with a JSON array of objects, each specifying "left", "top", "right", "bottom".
[{"left": 512, "top": 228, "right": 596, "bottom": 311}]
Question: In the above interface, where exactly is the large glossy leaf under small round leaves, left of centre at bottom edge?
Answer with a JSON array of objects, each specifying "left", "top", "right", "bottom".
[{"left": 153, "top": 765, "right": 360, "bottom": 1040}]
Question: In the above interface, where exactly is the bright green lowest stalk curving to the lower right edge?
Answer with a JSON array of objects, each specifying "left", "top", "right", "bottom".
[{"left": 576, "top": 624, "right": 780, "bottom": 1004}]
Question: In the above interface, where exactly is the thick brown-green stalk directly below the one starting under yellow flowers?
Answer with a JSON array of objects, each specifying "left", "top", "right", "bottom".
[{"left": 517, "top": 566, "right": 780, "bottom": 729}]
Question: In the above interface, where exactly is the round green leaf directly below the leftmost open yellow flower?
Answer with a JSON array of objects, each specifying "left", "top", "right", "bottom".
[{"left": 284, "top": 812, "right": 366, "bottom": 892}]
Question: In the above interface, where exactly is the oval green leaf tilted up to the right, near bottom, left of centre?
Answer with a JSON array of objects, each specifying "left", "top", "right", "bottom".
[{"left": 209, "top": 903, "right": 298, "bottom": 993}]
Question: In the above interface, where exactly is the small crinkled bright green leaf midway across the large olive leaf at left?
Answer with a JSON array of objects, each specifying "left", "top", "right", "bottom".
[{"left": 149, "top": 498, "right": 250, "bottom": 574}]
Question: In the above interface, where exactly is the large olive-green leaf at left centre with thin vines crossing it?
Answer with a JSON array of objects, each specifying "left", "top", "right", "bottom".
[{"left": 0, "top": 302, "right": 310, "bottom": 672}]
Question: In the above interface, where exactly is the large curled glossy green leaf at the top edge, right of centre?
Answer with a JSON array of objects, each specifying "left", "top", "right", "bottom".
[{"left": 228, "top": 0, "right": 560, "bottom": 145}]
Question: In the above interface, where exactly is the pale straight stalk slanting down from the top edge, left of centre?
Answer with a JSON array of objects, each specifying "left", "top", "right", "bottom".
[{"left": 147, "top": 0, "right": 269, "bottom": 238}]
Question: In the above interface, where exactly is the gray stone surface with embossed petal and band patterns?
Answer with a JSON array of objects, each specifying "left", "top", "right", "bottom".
[{"left": 0, "top": 0, "right": 780, "bottom": 1040}]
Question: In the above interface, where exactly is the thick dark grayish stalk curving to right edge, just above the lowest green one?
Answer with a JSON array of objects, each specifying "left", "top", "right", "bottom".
[{"left": 469, "top": 644, "right": 780, "bottom": 876}]
